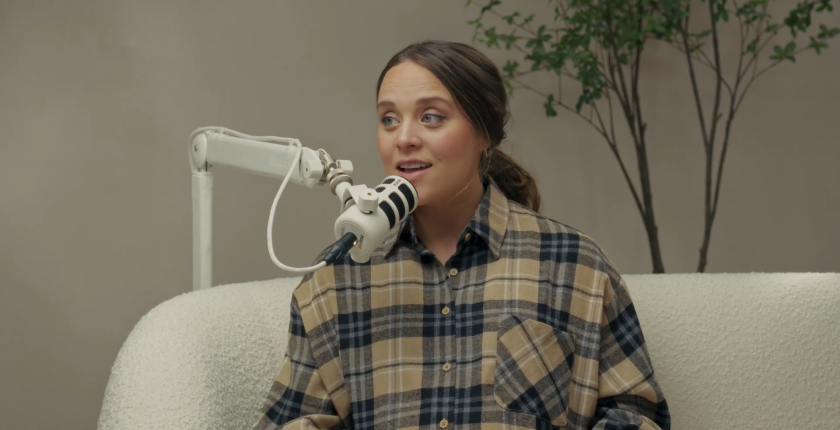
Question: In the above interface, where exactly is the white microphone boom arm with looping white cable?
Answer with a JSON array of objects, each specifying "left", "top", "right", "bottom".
[{"left": 189, "top": 127, "right": 416, "bottom": 290}]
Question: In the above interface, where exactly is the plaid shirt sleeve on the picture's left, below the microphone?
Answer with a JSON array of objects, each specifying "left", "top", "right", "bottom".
[{"left": 255, "top": 299, "right": 345, "bottom": 430}]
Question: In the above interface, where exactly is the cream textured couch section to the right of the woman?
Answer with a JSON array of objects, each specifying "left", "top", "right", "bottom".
[{"left": 625, "top": 273, "right": 840, "bottom": 430}]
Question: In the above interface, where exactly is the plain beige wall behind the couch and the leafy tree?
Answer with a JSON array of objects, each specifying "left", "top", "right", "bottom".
[{"left": 0, "top": 0, "right": 840, "bottom": 430}]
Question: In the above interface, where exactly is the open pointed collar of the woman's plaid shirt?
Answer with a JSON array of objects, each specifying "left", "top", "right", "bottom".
[{"left": 382, "top": 178, "right": 510, "bottom": 258}]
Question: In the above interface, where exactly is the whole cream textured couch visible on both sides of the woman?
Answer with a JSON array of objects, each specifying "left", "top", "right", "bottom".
[{"left": 99, "top": 273, "right": 840, "bottom": 430}]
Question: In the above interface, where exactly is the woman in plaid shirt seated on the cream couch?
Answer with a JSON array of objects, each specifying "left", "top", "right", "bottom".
[{"left": 258, "top": 42, "right": 670, "bottom": 429}]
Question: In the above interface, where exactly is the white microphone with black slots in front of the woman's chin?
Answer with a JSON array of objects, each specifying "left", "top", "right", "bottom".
[{"left": 324, "top": 176, "right": 418, "bottom": 264}]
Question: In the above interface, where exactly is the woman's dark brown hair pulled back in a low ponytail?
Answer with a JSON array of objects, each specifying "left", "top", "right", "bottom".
[{"left": 376, "top": 41, "right": 541, "bottom": 212}]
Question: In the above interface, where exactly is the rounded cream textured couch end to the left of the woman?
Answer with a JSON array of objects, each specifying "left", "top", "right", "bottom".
[{"left": 99, "top": 277, "right": 300, "bottom": 430}]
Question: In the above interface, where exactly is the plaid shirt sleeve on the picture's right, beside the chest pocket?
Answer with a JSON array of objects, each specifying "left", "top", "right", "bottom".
[{"left": 592, "top": 267, "right": 671, "bottom": 430}]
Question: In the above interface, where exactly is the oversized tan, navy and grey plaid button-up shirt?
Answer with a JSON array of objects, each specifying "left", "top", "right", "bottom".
[{"left": 257, "top": 180, "right": 670, "bottom": 430}]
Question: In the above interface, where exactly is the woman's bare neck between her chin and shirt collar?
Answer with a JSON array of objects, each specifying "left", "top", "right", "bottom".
[{"left": 411, "top": 179, "right": 484, "bottom": 263}]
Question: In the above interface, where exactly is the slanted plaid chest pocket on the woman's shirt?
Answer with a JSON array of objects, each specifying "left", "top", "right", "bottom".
[{"left": 494, "top": 315, "right": 575, "bottom": 427}]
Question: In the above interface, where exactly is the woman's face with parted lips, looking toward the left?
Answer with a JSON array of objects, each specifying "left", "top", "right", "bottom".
[{"left": 377, "top": 61, "right": 486, "bottom": 206}]
